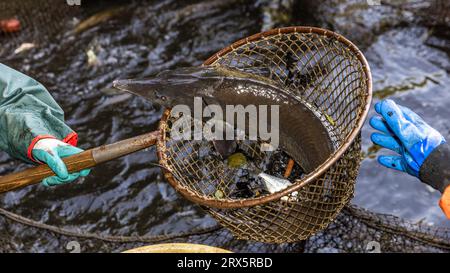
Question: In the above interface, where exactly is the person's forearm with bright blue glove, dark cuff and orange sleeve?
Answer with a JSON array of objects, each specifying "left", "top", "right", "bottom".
[{"left": 370, "top": 100, "right": 450, "bottom": 219}]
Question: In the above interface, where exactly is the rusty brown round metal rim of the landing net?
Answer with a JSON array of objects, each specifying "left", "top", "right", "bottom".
[{"left": 157, "top": 26, "right": 372, "bottom": 209}]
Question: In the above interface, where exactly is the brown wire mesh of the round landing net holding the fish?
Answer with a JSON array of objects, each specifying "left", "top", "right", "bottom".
[{"left": 158, "top": 28, "right": 370, "bottom": 243}]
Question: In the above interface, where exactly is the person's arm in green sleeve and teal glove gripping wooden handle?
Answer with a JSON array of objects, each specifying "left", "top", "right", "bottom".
[{"left": 0, "top": 64, "right": 89, "bottom": 185}]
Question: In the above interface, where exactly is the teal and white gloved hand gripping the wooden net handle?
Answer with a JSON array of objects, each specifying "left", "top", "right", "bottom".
[{"left": 32, "top": 138, "right": 90, "bottom": 186}]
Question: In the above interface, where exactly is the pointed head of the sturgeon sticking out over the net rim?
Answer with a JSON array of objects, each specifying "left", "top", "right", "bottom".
[{"left": 113, "top": 67, "right": 221, "bottom": 107}]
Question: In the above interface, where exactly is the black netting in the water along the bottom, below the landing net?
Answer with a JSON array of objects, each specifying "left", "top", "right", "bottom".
[{"left": 0, "top": 205, "right": 450, "bottom": 253}]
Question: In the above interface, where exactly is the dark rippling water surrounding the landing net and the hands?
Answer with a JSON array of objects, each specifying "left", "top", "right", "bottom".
[{"left": 0, "top": 0, "right": 450, "bottom": 251}]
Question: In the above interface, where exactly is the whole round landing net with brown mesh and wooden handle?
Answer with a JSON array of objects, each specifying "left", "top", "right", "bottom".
[{"left": 0, "top": 27, "right": 372, "bottom": 243}]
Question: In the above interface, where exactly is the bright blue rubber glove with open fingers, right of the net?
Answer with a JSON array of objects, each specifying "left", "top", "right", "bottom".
[{"left": 370, "top": 100, "right": 445, "bottom": 177}]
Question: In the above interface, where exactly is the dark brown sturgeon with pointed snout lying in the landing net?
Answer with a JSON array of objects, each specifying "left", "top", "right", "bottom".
[{"left": 113, "top": 66, "right": 333, "bottom": 173}]
